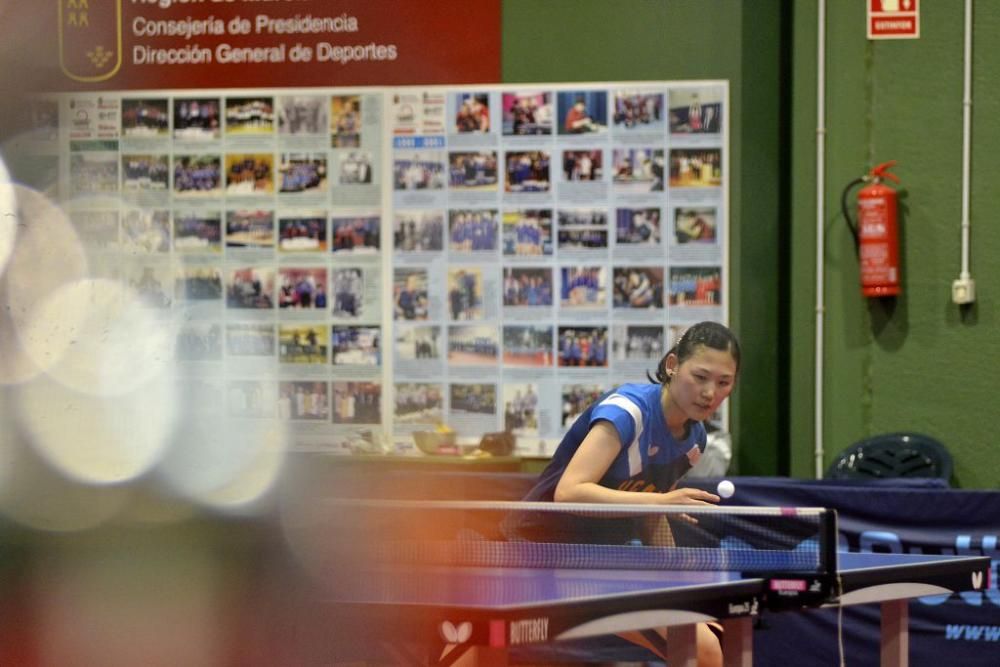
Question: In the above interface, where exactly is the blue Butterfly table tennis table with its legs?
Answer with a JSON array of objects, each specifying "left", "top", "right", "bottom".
[{"left": 316, "top": 504, "right": 990, "bottom": 667}]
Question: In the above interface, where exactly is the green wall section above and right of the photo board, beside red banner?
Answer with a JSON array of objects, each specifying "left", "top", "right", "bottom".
[{"left": 502, "top": 0, "right": 788, "bottom": 475}]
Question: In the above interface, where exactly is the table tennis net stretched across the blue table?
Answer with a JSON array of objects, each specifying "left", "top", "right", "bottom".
[{"left": 326, "top": 501, "right": 836, "bottom": 573}]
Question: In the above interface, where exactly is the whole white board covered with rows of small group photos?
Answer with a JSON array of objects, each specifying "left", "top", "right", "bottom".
[{"left": 35, "top": 81, "right": 729, "bottom": 456}]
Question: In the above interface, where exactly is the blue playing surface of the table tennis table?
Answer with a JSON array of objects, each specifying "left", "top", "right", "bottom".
[{"left": 332, "top": 552, "right": 972, "bottom": 609}]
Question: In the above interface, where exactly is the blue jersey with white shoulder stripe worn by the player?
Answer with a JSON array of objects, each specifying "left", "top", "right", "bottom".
[{"left": 524, "top": 384, "right": 708, "bottom": 501}]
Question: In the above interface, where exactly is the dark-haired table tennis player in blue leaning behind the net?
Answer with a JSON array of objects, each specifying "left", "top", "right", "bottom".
[{"left": 517, "top": 322, "right": 740, "bottom": 665}]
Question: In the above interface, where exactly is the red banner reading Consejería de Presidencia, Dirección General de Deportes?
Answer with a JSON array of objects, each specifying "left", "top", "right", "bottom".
[{"left": 8, "top": 0, "right": 500, "bottom": 91}]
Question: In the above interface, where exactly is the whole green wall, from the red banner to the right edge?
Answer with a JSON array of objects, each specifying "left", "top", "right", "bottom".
[{"left": 502, "top": 0, "right": 1000, "bottom": 488}]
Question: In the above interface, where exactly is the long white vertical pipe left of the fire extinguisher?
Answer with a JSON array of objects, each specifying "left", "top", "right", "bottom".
[{"left": 813, "top": 0, "right": 826, "bottom": 479}]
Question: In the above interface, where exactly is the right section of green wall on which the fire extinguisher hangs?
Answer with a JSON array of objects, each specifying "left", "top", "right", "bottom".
[{"left": 788, "top": 1, "right": 1000, "bottom": 488}]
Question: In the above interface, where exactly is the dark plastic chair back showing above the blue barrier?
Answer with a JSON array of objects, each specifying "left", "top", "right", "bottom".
[{"left": 826, "top": 433, "right": 952, "bottom": 481}]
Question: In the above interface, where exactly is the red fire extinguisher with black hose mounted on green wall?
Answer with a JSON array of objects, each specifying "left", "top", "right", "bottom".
[{"left": 841, "top": 160, "right": 900, "bottom": 297}]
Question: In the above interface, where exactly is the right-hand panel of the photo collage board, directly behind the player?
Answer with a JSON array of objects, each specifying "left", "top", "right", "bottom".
[{"left": 387, "top": 82, "right": 728, "bottom": 455}]
